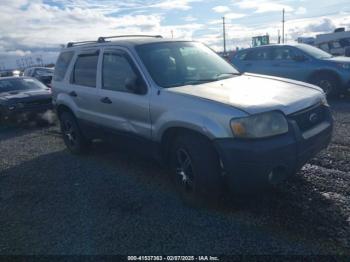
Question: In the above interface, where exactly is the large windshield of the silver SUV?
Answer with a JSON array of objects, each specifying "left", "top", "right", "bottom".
[{"left": 136, "top": 42, "right": 239, "bottom": 88}]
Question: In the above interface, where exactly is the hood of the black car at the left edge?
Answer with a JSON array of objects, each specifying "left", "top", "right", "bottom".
[{"left": 0, "top": 89, "right": 51, "bottom": 102}]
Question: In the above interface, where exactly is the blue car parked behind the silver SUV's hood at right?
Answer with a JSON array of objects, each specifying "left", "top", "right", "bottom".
[{"left": 232, "top": 44, "right": 350, "bottom": 96}]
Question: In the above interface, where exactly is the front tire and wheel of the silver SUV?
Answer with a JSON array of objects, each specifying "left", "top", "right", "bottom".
[{"left": 170, "top": 134, "right": 223, "bottom": 205}]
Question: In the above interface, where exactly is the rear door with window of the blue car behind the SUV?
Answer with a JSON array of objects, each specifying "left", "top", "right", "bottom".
[{"left": 244, "top": 47, "right": 271, "bottom": 75}]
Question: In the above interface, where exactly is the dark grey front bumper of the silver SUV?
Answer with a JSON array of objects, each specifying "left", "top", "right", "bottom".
[{"left": 214, "top": 106, "right": 333, "bottom": 191}]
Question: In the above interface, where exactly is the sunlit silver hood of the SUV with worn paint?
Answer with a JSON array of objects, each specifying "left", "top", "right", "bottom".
[{"left": 166, "top": 74, "right": 324, "bottom": 115}]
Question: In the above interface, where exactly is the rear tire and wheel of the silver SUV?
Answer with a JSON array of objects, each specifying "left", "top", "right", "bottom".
[{"left": 60, "top": 112, "right": 90, "bottom": 154}]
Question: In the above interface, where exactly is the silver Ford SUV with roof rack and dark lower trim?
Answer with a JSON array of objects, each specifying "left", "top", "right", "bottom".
[{"left": 53, "top": 36, "right": 333, "bottom": 202}]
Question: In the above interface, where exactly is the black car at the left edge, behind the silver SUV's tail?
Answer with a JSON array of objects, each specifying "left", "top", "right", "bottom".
[{"left": 0, "top": 77, "right": 52, "bottom": 124}]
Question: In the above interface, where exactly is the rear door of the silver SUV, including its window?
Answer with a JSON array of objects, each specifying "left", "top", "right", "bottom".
[{"left": 67, "top": 49, "right": 100, "bottom": 123}]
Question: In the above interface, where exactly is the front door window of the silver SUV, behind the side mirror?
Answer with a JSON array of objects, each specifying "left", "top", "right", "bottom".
[{"left": 102, "top": 51, "right": 143, "bottom": 92}]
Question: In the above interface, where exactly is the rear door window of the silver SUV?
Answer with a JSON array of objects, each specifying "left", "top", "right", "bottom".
[{"left": 71, "top": 52, "right": 99, "bottom": 87}]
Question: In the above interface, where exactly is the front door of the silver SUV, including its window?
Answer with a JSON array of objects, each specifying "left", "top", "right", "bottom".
[{"left": 98, "top": 48, "right": 151, "bottom": 138}]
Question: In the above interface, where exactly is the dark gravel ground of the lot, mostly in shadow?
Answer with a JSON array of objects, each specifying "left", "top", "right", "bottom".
[{"left": 0, "top": 99, "right": 350, "bottom": 255}]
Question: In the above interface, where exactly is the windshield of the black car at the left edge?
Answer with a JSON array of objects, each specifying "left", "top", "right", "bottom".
[{"left": 0, "top": 78, "right": 47, "bottom": 93}]
